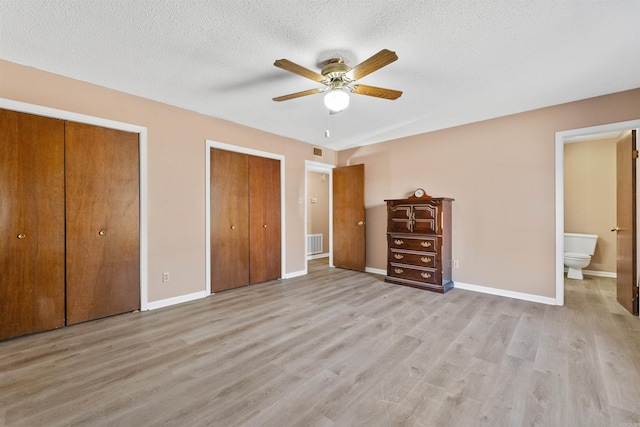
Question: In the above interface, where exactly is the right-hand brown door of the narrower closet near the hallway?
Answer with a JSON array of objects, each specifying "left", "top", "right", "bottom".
[{"left": 249, "top": 156, "right": 281, "bottom": 284}]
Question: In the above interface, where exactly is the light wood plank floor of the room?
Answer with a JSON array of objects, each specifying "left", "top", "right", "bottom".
[{"left": 0, "top": 260, "right": 640, "bottom": 427}]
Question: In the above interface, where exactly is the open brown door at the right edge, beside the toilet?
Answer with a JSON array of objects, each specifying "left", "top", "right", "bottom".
[{"left": 615, "top": 130, "right": 638, "bottom": 314}]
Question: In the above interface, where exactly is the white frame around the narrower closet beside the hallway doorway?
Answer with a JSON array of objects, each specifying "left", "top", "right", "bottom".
[{"left": 204, "top": 139, "right": 287, "bottom": 295}]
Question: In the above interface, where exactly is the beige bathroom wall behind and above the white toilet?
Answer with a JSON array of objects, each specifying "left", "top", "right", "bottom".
[{"left": 564, "top": 139, "right": 616, "bottom": 273}]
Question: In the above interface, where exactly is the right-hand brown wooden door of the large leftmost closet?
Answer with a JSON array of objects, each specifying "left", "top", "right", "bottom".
[{"left": 65, "top": 122, "right": 140, "bottom": 324}]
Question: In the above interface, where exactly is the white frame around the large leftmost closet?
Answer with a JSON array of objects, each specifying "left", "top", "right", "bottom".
[{"left": 0, "top": 98, "right": 149, "bottom": 311}]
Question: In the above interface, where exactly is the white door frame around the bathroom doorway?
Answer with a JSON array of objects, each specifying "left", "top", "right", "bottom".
[{"left": 555, "top": 119, "right": 640, "bottom": 305}]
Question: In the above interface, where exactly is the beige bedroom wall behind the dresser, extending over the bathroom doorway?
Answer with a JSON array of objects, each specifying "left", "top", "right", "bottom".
[{"left": 338, "top": 89, "right": 640, "bottom": 298}]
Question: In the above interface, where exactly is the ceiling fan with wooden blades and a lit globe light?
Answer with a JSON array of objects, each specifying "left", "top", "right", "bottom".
[{"left": 273, "top": 49, "right": 402, "bottom": 113}]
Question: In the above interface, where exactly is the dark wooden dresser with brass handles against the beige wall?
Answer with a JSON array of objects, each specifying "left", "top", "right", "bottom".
[{"left": 385, "top": 197, "right": 453, "bottom": 293}]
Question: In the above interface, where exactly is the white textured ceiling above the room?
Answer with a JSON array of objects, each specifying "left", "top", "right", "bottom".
[{"left": 0, "top": 0, "right": 640, "bottom": 149}]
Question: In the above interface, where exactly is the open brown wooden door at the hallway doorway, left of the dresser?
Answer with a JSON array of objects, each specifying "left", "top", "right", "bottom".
[{"left": 333, "top": 165, "right": 366, "bottom": 271}]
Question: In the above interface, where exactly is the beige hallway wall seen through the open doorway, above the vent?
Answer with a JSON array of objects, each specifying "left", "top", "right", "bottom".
[{"left": 307, "top": 172, "right": 329, "bottom": 253}]
